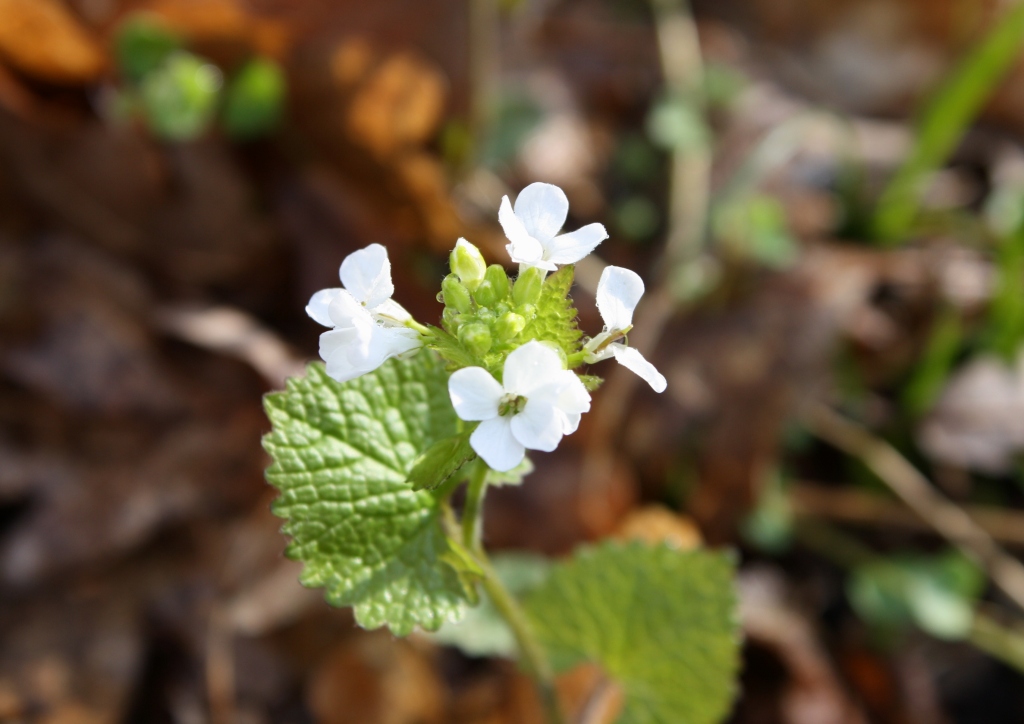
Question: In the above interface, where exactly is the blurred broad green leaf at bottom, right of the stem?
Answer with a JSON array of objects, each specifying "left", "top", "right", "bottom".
[{"left": 525, "top": 543, "right": 739, "bottom": 724}]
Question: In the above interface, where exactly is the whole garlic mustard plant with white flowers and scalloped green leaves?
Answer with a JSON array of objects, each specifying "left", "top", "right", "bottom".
[{"left": 264, "top": 183, "right": 738, "bottom": 724}]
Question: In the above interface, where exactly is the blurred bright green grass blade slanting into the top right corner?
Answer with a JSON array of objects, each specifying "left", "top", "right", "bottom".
[{"left": 873, "top": 4, "right": 1024, "bottom": 245}]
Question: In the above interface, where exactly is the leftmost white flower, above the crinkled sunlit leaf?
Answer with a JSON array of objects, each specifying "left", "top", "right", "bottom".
[{"left": 306, "top": 244, "right": 422, "bottom": 382}]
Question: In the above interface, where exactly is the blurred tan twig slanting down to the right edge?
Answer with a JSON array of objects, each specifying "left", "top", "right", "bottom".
[{"left": 805, "top": 404, "right": 1024, "bottom": 610}]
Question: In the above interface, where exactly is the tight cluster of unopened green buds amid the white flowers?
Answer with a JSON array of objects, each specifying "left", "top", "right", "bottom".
[{"left": 439, "top": 239, "right": 544, "bottom": 357}]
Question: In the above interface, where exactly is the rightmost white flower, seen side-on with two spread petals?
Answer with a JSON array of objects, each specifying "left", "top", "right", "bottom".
[{"left": 584, "top": 266, "right": 669, "bottom": 392}]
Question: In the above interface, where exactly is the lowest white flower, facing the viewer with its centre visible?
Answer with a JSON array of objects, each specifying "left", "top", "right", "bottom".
[{"left": 449, "top": 341, "right": 590, "bottom": 472}]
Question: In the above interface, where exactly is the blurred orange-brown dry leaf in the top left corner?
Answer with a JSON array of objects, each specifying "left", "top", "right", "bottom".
[{"left": 0, "top": 0, "right": 106, "bottom": 85}]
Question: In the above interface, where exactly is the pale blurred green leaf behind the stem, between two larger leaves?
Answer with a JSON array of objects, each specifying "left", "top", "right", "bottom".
[{"left": 433, "top": 553, "right": 551, "bottom": 658}]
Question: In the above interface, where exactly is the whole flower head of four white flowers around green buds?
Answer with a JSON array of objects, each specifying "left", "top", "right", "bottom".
[{"left": 306, "top": 183, "right": 667, "bottom": 471}]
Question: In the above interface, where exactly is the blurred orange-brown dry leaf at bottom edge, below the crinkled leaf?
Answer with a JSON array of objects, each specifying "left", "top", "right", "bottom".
[{"left": 307, "top": 631, "right": 445, "bottom": 724}]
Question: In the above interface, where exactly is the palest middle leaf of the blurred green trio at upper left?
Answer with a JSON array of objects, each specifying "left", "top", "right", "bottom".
[{"left": 140, "top": 52, "right": 221, "bottom": 140}]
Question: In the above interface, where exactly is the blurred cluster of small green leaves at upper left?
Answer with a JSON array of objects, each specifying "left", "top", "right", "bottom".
[{"left": 114, "top": 13, "right": 287, "bottom": 141}]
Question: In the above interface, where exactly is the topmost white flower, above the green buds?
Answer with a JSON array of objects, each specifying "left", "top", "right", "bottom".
[{"left": 498, "top": 183, "right": 608, "bottom": 271}]
